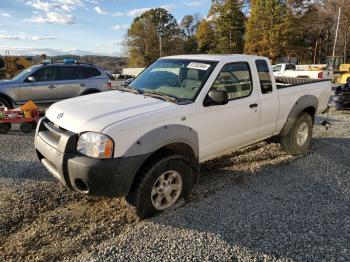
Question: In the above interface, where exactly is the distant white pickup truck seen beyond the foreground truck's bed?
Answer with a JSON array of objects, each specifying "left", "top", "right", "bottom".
[{"left": 272, "top": 63, "right": 333, "bottom": 80}]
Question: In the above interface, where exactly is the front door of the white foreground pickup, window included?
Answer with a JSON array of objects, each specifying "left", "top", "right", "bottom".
[{"left": 198, "top": 62, "right": 260, "bottom": 160}]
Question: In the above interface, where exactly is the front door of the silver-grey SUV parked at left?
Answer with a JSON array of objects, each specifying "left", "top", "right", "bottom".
[{"left": 19, "top": 66, "right": 58, "bottom": 103}]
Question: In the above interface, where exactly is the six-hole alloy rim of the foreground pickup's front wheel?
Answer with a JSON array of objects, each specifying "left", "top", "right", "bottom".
[{"left": 151, "top": 171, "right": 182, "bottom": 210}]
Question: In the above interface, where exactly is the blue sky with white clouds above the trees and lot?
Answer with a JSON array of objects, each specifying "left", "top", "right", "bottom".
[{"left": 0, "top": 0, "right": 211, "bottom": 56}]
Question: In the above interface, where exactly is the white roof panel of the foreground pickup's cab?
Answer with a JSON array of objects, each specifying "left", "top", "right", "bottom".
[{"left": 162, "top": 54, "right": 267, "bottom": 61}]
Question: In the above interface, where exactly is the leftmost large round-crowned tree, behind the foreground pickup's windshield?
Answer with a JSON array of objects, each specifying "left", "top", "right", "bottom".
[{"left": 126, "top": 8, "right": 182, "bottom": 67}]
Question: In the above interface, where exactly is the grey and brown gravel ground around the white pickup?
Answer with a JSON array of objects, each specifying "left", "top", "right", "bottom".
[{"left": 0, "top": 111, "right": 350, "bottom": 261}]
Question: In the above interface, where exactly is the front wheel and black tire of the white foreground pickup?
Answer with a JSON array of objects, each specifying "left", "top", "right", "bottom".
[{"left": 126, "top": 154, "right": 193, "bottom": 219}]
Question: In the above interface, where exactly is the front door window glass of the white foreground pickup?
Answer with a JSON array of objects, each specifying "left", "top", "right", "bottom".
[{"left": 212, "top": 62, "right": 253, "bottom": 100}]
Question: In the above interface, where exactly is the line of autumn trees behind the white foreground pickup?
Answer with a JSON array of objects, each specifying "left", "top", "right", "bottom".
[{"left": 125, "top": 0, "right": 350, "bottom": 67}]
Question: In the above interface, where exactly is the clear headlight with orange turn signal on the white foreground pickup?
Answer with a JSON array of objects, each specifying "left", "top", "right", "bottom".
[{"left": 77, "top": 132, "right": 114, "bottom": 158}]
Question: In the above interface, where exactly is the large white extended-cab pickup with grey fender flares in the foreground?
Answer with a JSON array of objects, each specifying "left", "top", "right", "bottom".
[{"left": 35, "top": 55, "right": 331, "bottom": 218}]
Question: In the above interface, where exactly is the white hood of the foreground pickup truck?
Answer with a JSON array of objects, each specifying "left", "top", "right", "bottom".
[{"left": 46, "top": 91, "right": 176, "bottom": 133}]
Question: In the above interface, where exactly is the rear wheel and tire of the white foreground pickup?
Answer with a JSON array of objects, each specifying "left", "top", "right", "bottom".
[{"left": 281, "top": 113, "right": 313, "bottom": 155}]
